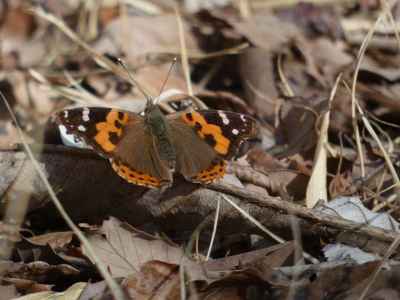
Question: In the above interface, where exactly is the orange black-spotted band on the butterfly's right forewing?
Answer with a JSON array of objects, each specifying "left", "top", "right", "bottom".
[{"left": 182, "top": 112, "right": 230, "bottom": 155}]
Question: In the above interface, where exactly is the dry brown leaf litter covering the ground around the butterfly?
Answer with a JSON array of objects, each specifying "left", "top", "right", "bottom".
[{"left": 0, "top": 0, "right": 400, "bottom": 299}]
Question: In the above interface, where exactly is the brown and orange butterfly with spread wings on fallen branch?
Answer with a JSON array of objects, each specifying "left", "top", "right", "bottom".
[{"left": 55, "top": 101, "right": 258, "bottom": 188}]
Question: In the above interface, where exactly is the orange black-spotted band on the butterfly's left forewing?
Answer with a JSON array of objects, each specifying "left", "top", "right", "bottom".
[{"left": 94, "top": 110, "right": 129, "bottom": 152}]
